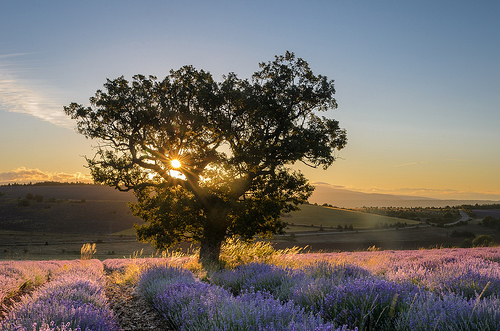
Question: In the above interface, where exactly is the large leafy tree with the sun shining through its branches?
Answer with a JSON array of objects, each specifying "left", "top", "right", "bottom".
[{"left": 64, "top": 52, "right": 346, "bottom": 265}]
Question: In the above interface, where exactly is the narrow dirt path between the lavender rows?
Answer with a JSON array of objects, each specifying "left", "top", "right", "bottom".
[{"left": 106, "top": 275, "right": 170, "bottom": 331}]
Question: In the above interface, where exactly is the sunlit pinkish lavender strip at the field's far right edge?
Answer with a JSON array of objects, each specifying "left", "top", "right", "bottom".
[{"left": 280, "top": 247, "right": 500, "bottom": 299}]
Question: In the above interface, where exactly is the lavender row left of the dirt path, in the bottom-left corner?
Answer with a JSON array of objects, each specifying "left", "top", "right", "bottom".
[{"left": 0, "top": 260, "right": 119, "bottom": 331}]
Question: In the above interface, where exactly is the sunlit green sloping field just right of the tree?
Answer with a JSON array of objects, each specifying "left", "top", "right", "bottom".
[{"left": 283, "top": 205, "right": 420, "bottom": 232}]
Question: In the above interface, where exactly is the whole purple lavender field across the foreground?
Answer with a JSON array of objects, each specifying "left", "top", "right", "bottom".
[{"left": 0, "top": 247, "right": 500, "bottom": 331}]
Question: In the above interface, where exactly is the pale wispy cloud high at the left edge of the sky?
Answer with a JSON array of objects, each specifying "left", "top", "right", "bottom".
[{"left": 0, "top": 58, "right": 74, "bottom": 128}]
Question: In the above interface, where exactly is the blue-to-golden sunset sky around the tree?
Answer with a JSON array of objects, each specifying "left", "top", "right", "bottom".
[{"left": 0, "top": 0, "right": 500, "bottom": 200}]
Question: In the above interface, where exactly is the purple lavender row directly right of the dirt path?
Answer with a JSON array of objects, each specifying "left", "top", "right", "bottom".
[{"left": 138, "top": 267, "right": 348, "bottom": 331}]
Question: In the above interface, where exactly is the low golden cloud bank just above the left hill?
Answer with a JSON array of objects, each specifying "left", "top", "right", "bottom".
[{"left": 0, "top": 167, "right": 92, "bottom": 185}]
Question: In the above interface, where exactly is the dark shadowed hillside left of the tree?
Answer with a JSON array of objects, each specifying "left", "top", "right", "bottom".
[{"left": 0, "top": 185, "right": 142, "bottom": 234}]
